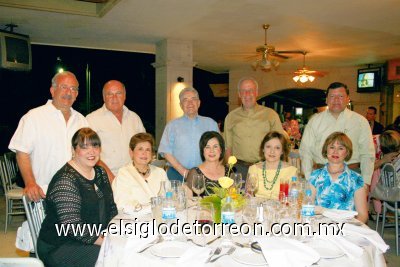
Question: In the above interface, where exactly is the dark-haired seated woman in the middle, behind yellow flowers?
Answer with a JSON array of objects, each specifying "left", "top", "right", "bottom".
[{"left": 185, "top": 131, "right": 228, "bottom": 197}]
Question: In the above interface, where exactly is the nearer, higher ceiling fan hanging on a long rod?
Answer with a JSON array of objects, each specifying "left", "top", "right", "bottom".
[{"left": 251, "top": 24, "right": 302, "bottom": 71}]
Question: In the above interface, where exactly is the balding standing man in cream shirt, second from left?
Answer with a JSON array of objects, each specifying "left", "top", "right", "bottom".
[{"left": 86, "top": 80, "right": 146, "bottom": 183}]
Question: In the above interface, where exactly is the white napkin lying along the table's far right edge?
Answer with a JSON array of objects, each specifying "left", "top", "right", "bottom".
[{"left": 343, "top": 223, "right": 389, "bottom": 253}]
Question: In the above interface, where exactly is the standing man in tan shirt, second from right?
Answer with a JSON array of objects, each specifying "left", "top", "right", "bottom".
[{"left": 224, "top": 77, "right": 284, "bottom": 179}]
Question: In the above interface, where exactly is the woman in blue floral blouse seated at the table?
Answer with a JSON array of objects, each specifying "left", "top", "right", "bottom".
[{"left": 309, "top": 132, "right": 368, "bottom": 223}]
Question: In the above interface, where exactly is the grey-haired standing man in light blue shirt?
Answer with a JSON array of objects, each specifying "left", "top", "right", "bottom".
[{"left": 158, "top": 88, "right": 219, "bottom": 181}]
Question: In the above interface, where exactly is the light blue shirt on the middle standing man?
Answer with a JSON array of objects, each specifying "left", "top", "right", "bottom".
[{"left": 158, "top": 115, "right": 219, "bottom": 169}]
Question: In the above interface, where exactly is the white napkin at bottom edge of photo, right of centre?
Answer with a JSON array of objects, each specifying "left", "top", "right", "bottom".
[{"left": 256, "top": 237, "right": 320, "bottom": 267}]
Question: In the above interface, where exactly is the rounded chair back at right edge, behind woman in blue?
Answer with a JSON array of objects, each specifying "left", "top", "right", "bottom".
[{"left": 371, "top": 163, "right": 400, "bottom": 202}]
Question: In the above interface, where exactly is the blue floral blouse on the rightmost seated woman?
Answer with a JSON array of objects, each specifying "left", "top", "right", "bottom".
[{"left": 309, "top": 164, "right": 364, "bottom": 213}]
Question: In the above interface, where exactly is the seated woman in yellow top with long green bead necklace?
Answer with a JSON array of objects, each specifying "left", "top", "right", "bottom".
[{"left": 249, "top": 131, "right": 297, "bottom": 200}]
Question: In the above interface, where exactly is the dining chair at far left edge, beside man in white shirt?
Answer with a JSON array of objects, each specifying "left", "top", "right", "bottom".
[{"left": 0, "top": 155, "right": 25, "bottom": 233}]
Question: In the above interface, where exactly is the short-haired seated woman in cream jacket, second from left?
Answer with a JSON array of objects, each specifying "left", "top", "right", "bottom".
[{"left": 112, "top": 133, "right": 168, "bottom": 210}]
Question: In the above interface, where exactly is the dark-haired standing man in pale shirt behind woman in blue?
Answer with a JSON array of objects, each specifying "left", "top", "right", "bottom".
[{"left": 299, "top": 82, "right": 375, "bottom": 185}]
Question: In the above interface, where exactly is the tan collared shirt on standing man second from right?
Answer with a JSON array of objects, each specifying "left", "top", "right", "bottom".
[{"left": 224, "top": 104, "right": 284, "bottom": 162}]
